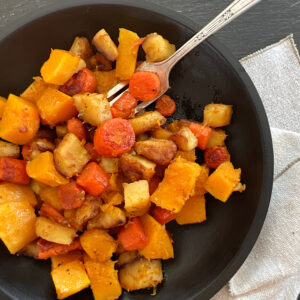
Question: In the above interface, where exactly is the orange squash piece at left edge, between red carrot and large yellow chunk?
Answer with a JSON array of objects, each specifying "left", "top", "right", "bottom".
[{"left": 0, "top": 182, "right": 37, "bottom": 206}]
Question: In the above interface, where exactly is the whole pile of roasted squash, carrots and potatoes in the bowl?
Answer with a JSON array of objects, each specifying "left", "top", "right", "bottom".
[{"left": 0, "top": 28, "right": 245, "bottom": 300}]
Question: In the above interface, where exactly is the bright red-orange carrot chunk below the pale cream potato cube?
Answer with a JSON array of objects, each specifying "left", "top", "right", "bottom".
[{"left": 118, "top": 217, "right": 148, "bottom": 251}]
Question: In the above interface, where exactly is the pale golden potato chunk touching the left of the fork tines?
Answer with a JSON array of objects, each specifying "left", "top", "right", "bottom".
[{"left": 73, "top": 93, "right": 112, "bottom": 126}]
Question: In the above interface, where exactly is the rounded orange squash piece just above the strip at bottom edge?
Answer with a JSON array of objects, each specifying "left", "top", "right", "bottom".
[{"left": 80, "top": 229, "right": 118, "bottom": 261}]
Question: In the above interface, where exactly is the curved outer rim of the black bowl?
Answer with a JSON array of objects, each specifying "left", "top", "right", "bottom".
[{"left": 0, "top": 0, "right": 274, "bottom": 300}]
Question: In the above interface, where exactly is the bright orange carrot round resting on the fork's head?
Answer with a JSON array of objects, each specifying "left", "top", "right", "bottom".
[{"left": 129, "top": 71, "right": 160, "bottom": 101}]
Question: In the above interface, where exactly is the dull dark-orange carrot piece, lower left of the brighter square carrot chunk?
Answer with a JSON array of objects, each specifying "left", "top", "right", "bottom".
[{"left": 58, "top": 181, "right": 85, "bottom": 209}]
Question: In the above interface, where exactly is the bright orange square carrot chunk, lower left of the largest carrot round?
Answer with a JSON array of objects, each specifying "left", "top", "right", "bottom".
[{"left": 77, "top": 162, "right": 109, "bottom": 196}]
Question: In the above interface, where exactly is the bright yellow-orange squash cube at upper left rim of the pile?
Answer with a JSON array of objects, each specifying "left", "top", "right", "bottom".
[{"left": 41, "top": 49, "right": 85, "bottom": 85}]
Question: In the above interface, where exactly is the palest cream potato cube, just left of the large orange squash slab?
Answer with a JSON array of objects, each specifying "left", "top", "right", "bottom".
[{"left": 123, "top": 180, "right": 150, "bottom": 216}]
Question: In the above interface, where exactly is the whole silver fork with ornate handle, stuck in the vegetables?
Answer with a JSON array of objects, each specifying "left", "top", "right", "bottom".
[{"left": 107, "top": 0, "right": 261, "bottom": 113}]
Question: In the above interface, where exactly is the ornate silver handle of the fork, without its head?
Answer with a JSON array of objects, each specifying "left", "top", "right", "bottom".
[{"left": 162, "top": 0, "right": 261, "bottom": 70}]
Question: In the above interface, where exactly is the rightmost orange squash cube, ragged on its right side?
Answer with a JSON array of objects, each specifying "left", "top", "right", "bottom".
[{"left": 204, "top": 161, "right": 241, "bottom": 202}]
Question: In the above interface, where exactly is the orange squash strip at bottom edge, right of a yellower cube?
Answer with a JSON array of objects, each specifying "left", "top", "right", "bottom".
[{"left": 84, "top": 257, "right": 122, "bottom": 300}]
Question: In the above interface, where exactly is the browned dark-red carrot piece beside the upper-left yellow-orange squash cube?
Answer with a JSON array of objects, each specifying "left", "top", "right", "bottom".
[{"left": 59, "top": 68, "right": 97, "bottom": 96}]
